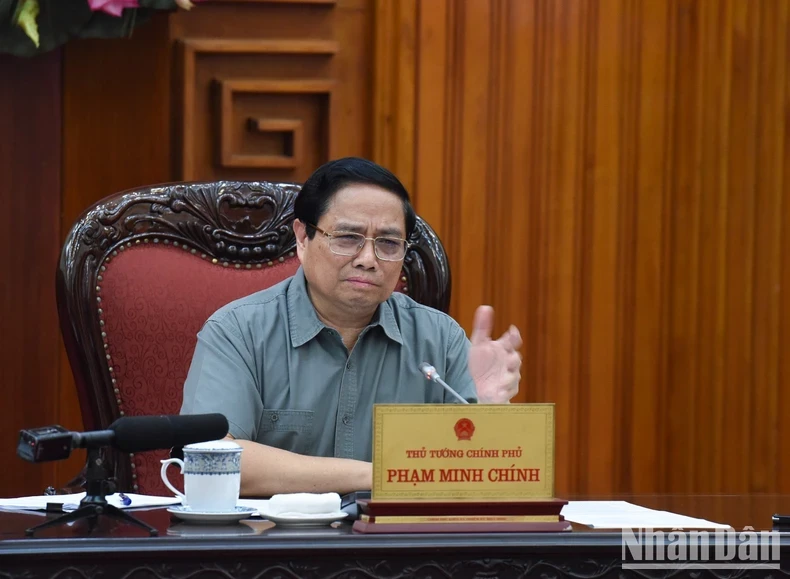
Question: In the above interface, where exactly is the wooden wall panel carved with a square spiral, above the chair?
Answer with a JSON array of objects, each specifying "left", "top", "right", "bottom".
[{"left": 171, "top": 0, "right": 373, "bottom": 181}]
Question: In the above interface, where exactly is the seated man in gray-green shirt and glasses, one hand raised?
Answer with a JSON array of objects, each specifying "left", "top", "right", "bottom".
[{"left": 181, "top": 158, "right": 521, "bottom": 496}]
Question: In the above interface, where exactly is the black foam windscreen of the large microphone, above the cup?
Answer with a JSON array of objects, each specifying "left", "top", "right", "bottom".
[{"left": 109, "top": 414, "right": 230, "bottom": 452}]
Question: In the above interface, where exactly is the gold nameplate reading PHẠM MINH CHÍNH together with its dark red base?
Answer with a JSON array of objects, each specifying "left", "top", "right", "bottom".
[{"left": 352, "top": 404, "right": 571, "bottom": 533}]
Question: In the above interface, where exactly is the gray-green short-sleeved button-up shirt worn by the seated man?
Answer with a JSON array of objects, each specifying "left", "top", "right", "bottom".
[{"left": 181, "top": 268, "right": 477, "bottom": 461}]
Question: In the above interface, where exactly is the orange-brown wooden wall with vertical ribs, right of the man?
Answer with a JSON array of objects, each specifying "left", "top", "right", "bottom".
[{"left": 374, "top": 0, "right": 790, "bottom": 495}]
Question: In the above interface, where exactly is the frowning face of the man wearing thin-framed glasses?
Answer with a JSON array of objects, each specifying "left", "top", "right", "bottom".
[{"left": 294, "top": 184, "right": 406, "bottom": 315}]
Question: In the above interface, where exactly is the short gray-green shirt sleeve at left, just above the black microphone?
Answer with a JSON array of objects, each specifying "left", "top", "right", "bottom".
[{"left": 181, "top": 318, "right": 263, "bottom": 440}]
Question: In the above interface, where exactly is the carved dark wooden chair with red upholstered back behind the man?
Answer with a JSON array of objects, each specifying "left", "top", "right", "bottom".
[{"left": 57, "top": 181, "right": 451, "bottom": 495}]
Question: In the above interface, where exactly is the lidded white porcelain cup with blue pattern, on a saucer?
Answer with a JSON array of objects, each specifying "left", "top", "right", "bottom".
[{"left": 161, "top": 440, "right": 242, "bottom": 513}]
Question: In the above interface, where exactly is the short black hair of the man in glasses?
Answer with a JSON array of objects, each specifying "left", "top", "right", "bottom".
[{"left": 294, "top": 157, "right": 417, "bottom": 239}]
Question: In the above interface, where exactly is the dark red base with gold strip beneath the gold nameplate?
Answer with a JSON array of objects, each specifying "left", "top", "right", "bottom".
[{"left": 352, "top": 499, "right": 571, "bottom": 534}]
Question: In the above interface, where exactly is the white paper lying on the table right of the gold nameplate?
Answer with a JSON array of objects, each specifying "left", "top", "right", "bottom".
[{"left": 562, "top": 501, "right": 731, "bottom": 529}]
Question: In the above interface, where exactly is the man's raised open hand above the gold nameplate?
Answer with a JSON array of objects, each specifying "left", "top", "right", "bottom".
[{"left": 469, "top": 306, "right": 522, "bottom": 404}]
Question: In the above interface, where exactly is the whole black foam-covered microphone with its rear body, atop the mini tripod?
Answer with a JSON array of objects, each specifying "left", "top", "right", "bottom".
[{"left": 17, "top": 414, "right": 229, "bottom": 462}]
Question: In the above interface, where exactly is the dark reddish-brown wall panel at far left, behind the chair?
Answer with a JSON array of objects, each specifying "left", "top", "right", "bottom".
[{"left": 0, "top": 50, "right": 62, "bottom": 497}]
